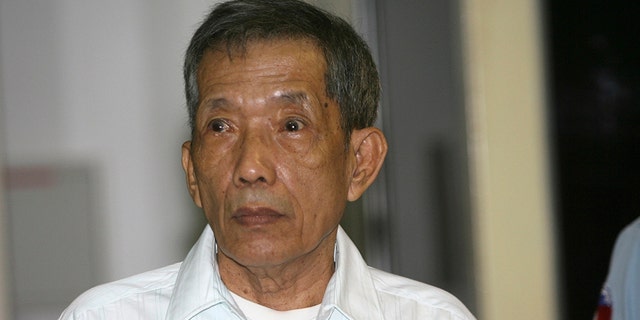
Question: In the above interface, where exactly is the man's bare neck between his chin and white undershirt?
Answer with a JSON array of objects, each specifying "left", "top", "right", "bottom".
[{"left": 217, "top": 232, "right": 336, "bottom": 311}]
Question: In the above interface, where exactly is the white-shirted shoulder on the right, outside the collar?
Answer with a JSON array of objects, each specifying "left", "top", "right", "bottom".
[{"left": 370, "top": 268, "right": 475, "bottom": 320}]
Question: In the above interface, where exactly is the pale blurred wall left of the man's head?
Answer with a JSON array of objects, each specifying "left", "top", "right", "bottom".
[{"left": 0, "top": 0, "right": 218, "bottom": 318}]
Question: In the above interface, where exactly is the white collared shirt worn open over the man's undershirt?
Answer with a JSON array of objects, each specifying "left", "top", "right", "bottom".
[{"left": 59, "top": 226, "right": 475, "bottom": 320}]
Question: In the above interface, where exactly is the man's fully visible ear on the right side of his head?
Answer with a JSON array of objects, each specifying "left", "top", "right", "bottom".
[{"left": 347, "top": 127, "right": 388, "bottom": 201}]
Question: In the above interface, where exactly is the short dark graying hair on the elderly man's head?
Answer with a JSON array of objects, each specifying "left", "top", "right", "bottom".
[{"left": 184, "top": 0, "right": 380, "bottom": 142}]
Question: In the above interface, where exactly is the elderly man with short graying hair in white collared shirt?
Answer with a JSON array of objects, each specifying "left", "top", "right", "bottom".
[{"left": 61, "top": 0, "right": 473, "bottom": 320}]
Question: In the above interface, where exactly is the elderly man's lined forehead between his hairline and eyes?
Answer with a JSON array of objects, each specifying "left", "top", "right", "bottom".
[{"left": 197, "top": 40, "right": 338, "bottom": 121}]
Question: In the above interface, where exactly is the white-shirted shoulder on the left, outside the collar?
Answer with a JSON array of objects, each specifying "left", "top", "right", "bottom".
[{"left": 60, "top": 263, "right": 181, "bottom": 319}]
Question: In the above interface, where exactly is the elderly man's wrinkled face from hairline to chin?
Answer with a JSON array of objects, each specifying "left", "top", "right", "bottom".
[{"left": 183, "top": 40, "right": 355, "bottom": 267}]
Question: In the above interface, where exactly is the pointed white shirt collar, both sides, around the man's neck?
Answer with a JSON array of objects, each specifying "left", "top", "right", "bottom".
[{"left": 167, "top": 226, "right": 382, "bottom": 320}]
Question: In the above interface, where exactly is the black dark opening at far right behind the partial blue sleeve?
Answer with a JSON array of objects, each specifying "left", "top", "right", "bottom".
[{"left": 546, "top": 0, "right": 640, "bottom": 319}]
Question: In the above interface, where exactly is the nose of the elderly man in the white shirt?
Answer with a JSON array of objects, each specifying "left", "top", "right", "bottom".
[{"left": 233, "top": 128, "right": 276, "bottom": 187}]
